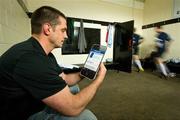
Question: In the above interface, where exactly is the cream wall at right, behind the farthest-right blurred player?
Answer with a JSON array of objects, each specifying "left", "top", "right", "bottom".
[{"left": 140, "top": 0, "right": 180, "bottom": 60}]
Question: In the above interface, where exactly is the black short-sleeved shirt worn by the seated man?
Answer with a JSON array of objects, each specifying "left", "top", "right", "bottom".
[{"left": 0, "top": 37, "right": 66, "bottom": 120}]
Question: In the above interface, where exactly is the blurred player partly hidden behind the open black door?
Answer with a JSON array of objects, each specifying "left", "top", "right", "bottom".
[{"left": 133, "top": 28, "right": 144, "bottom": 71}]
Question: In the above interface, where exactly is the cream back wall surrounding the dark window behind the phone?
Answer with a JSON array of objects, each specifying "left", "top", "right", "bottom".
[{"left": 27, "top": 0, "right": 143, "bottom": 64}]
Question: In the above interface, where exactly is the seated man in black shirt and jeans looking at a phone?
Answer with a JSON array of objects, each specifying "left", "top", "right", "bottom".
[{"left": 0, "top": 6, "right": 106, "bottom": 120}]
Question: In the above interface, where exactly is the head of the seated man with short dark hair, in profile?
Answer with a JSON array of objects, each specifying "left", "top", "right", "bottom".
[{"left": 31, "top": 6, "right": 67, "bottom": 48}]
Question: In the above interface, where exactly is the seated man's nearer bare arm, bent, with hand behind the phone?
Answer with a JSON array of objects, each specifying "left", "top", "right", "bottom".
[{"left": 43, "top": 64, "right": 106, "bottom": 116}]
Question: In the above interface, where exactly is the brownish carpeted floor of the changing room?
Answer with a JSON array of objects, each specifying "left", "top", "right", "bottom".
[{"left": 80, "top": 70, "right": 180, "bottom": 120}]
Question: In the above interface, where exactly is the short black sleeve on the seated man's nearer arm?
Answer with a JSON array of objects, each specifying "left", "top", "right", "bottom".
[{"left": 13, "top": 53, "right": 66, "bottom": 99}]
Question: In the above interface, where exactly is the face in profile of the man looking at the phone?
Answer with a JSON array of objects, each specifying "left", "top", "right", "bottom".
[{"left": 50, "top": 17, "right": 67, "bottom": 48}]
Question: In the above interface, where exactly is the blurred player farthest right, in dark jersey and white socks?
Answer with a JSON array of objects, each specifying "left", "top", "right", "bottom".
[{"left": 155, "top": 26, "right": 171, "bottom": 77}]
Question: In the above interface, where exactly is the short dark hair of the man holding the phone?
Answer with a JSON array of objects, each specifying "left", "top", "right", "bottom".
[{"left": 31, "top": 6, "right": 66, "bottom": 34}]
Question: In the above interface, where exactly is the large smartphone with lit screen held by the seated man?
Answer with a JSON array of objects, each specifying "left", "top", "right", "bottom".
[{"left": 80, "top": 44, "right": 107, "bottom": 80}]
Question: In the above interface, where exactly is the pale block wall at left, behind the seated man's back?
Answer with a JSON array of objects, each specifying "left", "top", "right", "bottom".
[{"left": 0, "top": 0, "right": 30, "bottom": 55}]
